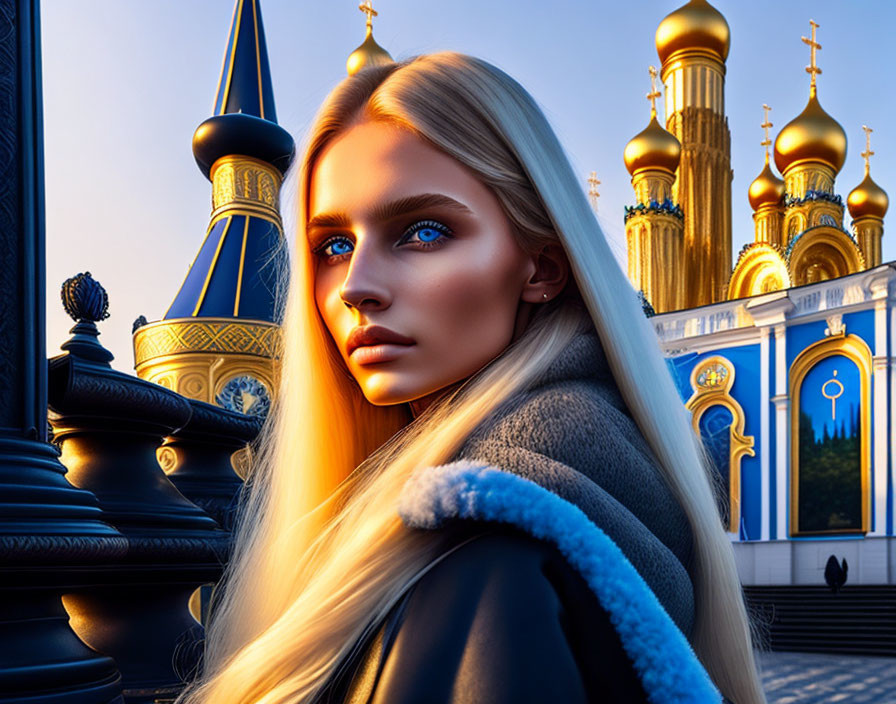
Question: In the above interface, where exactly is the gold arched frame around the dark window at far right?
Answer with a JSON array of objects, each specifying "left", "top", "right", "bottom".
[{"left": 788, "top": 328, "right": 871, "bottom": 536}]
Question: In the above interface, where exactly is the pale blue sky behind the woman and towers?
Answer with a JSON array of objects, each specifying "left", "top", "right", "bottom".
[{"left": 41, "top": 0, "right": 896, "bottom": 372}]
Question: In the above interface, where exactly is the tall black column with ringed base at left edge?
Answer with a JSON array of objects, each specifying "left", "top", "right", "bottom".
[{"left": 0, "top": 0, "right": 127, "bottom": 704}]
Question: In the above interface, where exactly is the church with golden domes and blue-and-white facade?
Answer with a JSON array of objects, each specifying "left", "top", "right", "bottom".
[{"left": 624, "top": 0, "right": 896, "bottom": 654}]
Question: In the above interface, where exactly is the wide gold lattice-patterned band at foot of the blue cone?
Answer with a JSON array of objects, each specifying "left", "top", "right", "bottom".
[{"left": 134, "top": 318, "right": 280, "bottom": 367}]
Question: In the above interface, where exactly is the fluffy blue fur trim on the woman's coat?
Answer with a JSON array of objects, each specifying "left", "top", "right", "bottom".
[{"left": 398, "top": 460, "right": 721, "bottom": 704}]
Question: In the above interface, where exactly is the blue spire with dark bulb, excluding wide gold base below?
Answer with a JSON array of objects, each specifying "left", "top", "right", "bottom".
[{"left": 164, "top": 0, "right": 295, "bottom": 322}]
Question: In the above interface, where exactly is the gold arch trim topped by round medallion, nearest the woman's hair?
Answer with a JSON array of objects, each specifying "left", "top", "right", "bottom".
[{"left": 685, "top": 355, "right": 756, "bottom": 533}]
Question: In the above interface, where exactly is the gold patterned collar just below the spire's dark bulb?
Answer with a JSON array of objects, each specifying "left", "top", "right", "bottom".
[{"left": 209, "top": 155, "right": 283, "bottom": 230}]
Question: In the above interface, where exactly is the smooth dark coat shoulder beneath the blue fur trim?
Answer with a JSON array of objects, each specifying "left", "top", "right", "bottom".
[{"left": 336, "top": 522, "right": 647, "bottom": 704}]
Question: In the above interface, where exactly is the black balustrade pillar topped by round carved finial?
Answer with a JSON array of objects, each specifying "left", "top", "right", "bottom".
[{"left": 49, "top": 273, "right": 229, "bottom": 704}]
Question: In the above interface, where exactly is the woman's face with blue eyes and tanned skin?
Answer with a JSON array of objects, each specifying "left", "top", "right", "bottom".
[{"left": 307, "top": 121, "right": 543, "bottom": 405}]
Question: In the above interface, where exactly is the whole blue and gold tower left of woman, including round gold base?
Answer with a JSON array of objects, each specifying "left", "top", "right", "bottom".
[{"left": 134, "top": 0, "right": 295, "bottom": 416}]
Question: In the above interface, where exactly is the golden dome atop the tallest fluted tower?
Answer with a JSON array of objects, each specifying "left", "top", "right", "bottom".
[{"left": 656, "top": 0, "right": 731, "bottom": 64}]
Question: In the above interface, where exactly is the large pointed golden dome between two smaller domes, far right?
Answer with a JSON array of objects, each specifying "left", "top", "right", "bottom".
[{"left": 775, "top": 88, "right": 846, "bottom": 174}]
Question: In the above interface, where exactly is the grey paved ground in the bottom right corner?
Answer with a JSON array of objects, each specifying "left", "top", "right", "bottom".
[{"left": 759, "top": 653, "right": 896, "bottom": 704}]
